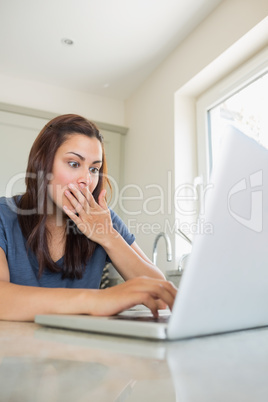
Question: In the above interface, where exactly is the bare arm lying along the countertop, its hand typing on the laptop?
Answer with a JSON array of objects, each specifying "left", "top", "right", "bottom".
[{"left": 0, "top": 248, "right": 176, "bottom": 321}]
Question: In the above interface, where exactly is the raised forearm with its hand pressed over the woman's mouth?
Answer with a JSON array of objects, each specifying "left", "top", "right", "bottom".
[{"left": 65, "top": 188, "right": 165, "bottom": 280}]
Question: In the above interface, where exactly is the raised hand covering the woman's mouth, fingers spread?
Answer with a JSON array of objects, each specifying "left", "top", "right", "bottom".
[{"left": 63, "top": 184, "right": 114, "bottom": 244}]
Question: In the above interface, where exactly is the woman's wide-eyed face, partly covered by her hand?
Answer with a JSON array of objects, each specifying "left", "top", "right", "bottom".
[{"left": 48, "top": 134, "right": 102, "bottom": 211}]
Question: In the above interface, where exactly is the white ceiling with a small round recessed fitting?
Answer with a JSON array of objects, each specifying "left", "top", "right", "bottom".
[{"left": 0, "top": 0, "right": 222, "bottom": 100}]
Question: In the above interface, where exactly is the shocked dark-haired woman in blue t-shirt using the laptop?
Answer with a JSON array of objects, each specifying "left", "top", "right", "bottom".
[{"left": 0, "top": 114, "right": 176, "bottom": 321}]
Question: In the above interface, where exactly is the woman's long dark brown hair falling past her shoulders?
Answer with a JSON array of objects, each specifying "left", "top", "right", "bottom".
[{"left": 16, "top": 114, "right": 111, "bottom": 279}]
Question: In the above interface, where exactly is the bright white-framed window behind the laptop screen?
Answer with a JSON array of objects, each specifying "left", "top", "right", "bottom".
[{"left": 197, "top": 46, "right": 268, "bottom": 181}]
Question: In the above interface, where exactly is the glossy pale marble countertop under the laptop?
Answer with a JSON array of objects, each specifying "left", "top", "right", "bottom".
[{"left": 0, "top": 322, "right": 268, "bottom": 402}]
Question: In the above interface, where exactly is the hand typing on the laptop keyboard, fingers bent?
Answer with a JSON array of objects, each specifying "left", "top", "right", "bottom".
[{"left": 89, "top": 277, "right": 177, "bottom": 318}]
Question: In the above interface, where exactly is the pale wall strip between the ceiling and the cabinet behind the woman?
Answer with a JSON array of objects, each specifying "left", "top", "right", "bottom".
[{"left": 0, "top": 74, "right": 125, "bottom": 126}]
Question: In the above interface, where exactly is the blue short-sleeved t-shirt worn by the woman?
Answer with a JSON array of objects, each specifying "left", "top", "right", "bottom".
[{"left": 0, "top": 197, "right": 135, "bottom": 289}]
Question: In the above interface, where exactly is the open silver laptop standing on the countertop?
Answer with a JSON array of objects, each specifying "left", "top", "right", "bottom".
[{"left": 35, "top": 127, "right": 268, "bottom": 340}]
